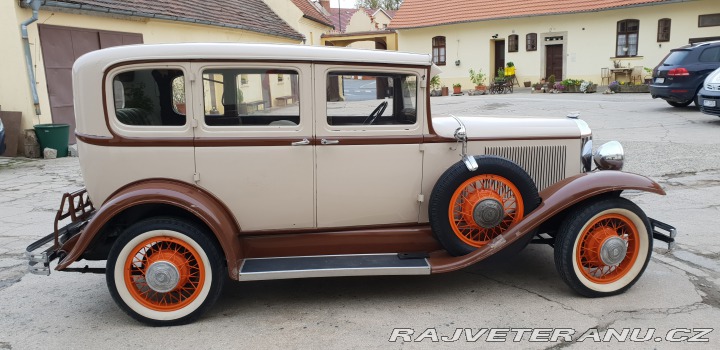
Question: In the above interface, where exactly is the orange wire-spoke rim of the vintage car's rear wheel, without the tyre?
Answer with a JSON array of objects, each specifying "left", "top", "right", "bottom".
[{"left": 124, "top": 236, "right": 205, "bottom": 311}]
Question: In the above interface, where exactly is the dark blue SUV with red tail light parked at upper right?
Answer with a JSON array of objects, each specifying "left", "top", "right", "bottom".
[{"left": 650, "top": 41, "right": 720, "bottom": 107}]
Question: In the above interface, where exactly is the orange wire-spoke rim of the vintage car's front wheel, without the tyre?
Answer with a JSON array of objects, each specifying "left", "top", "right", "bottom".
[{"left": 575, "top": 214, "right": 640, "bottom": 284}]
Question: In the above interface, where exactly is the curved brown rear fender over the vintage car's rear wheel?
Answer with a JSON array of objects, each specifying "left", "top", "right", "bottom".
[{"left": 55, "top": 179, "right": 241, "bottom": 277}]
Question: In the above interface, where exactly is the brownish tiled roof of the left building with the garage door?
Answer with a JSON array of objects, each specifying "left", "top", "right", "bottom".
[{"left": 47, "top": 0, "right": 304, "bottom": 40}]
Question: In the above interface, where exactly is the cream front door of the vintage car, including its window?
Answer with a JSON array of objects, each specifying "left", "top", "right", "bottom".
[{"left": 314, "top": 64, "right": 425, "bottom": 228}]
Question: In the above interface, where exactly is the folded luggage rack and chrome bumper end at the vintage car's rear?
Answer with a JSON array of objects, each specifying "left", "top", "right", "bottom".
[{"left": 25, "top": 189, "right": 95, "bottom": 276}]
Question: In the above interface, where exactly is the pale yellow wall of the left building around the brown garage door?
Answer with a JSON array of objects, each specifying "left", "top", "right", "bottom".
[{"left": 0, "top": 1, "right": 296, "bottom": 139}]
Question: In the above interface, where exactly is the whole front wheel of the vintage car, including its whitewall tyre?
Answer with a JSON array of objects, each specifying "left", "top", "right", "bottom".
[{"left": 555, "top": 197, "right": 652, "bottom": 297}]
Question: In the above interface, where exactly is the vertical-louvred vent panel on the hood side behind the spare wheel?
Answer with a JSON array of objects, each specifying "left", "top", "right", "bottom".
[{"left": 485, "top": 146, "right": 567, "bottom": 191}]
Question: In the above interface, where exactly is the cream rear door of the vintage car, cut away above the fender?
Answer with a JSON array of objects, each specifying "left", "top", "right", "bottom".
[{"left": 193, "top": 62, "right": 315, "bottom": 231}]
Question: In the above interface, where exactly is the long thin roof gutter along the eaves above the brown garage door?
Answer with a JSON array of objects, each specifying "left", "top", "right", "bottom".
[{"left": 36, "top": 0, "right": 305, "bottom": 40}]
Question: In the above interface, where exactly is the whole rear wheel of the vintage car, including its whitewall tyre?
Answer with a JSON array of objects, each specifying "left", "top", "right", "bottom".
[{"left": 106, "top": 218, "right": 225, "bottom": 326}]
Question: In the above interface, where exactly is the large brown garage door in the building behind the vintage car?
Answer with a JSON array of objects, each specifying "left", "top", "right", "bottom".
[{"left": 38, "top": 24, "right": 143, "bottom": 143}]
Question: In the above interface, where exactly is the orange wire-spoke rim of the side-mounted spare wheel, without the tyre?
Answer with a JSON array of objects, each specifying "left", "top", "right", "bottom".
[{"left": 448, "top": 174, "right": 524, "bottom": 247}]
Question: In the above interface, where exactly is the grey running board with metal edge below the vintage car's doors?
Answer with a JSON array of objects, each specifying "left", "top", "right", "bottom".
[{"left": 238, "top": 254, "right": 430, "bottom": 281}]
